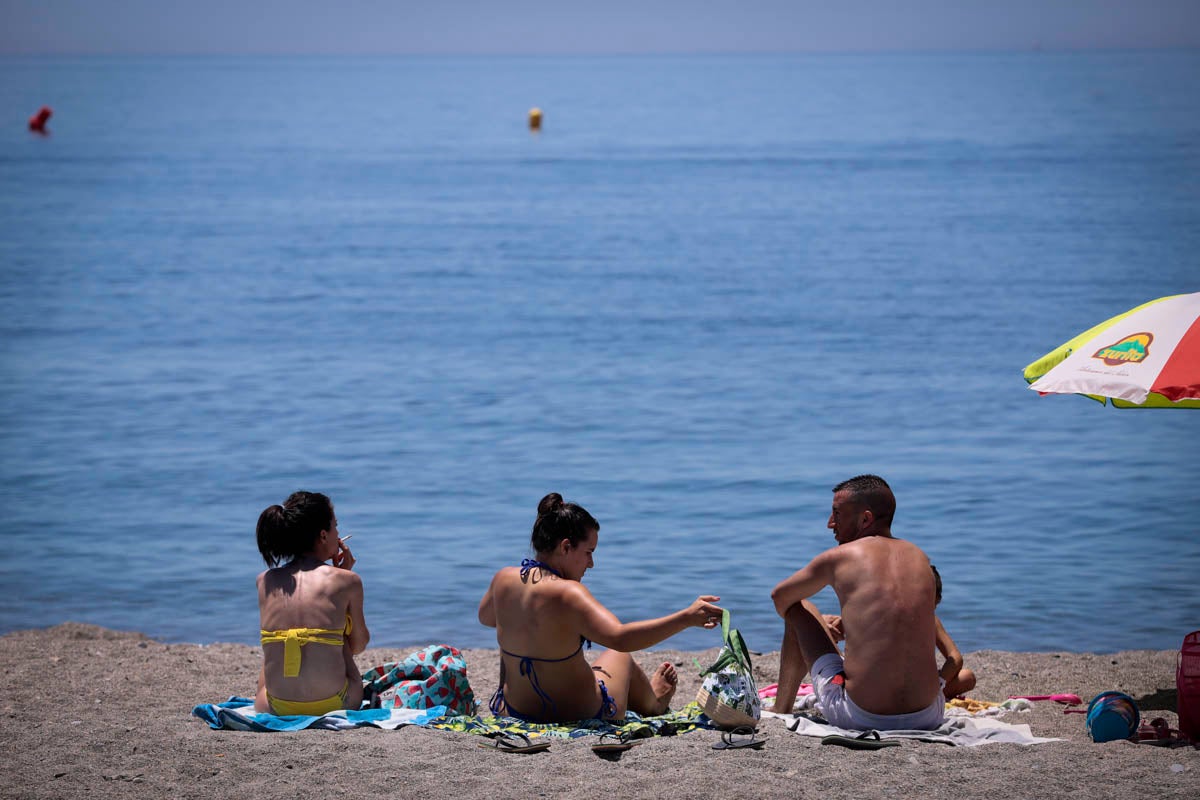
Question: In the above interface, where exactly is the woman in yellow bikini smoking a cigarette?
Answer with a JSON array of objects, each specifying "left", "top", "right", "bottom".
[{"left": 254, "top": 492, "right": 371, "bottom": 716}]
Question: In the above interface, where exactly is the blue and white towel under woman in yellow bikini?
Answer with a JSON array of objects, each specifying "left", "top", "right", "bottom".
[{"left": 192, "top": 697, "right": 446, "bottom": 733}]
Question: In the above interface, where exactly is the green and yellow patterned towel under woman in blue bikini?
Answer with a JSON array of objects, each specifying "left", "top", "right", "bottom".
[{"left": 426, "top": 703, "right": 718, "bottom": 739}]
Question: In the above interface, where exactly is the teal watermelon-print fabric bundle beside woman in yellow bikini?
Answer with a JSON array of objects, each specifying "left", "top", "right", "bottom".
[{"left": 362, "top": 644, "right": 475, "bottom": 715}]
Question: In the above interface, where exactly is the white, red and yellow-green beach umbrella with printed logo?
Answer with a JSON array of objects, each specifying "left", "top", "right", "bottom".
[{"left": 1025, "top": 291, "right": 1200, "bottom": 408}]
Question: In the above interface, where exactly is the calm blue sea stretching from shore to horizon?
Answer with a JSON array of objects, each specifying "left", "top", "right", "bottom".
[{"left": 0, "top": 52, "right": 1200, "bottom": 651}]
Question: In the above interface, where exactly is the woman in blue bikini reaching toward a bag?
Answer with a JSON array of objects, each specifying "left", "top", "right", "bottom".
[{"left": 479, "top": 493, "right": 722, "bottom": 722}]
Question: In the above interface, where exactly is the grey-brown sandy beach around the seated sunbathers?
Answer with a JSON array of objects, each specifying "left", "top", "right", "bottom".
[{"left": 0, "top": 624, "right": 1200, "bottom": 800}]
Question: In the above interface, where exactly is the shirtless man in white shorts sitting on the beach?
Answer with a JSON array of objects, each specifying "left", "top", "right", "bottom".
[{"left": 770, "top": 475, "right": 944, "bottom": 730}]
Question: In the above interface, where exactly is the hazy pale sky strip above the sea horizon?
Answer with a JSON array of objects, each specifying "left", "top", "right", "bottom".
[{"left": 0, "top": 0, "right": 1200, "bottom": 54}]
